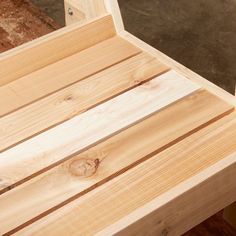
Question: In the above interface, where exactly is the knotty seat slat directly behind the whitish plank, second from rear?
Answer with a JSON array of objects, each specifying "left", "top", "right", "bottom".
[{"left": 0, "top": 53, "right": 168, "bottom": 152}]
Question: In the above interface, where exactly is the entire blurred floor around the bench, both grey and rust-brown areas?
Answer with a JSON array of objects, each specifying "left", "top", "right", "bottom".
[{"left": 0, "top": 0, "right": 236, "bottom": 236}]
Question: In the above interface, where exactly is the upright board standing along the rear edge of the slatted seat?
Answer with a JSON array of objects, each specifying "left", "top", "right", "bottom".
[{"left": 0, "top": 15, "right": 116, "bottom": 86}]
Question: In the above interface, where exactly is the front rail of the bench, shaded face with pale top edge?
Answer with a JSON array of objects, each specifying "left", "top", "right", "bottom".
[{"left": 101, "top": 152, "right": 236, "bottom": 236}]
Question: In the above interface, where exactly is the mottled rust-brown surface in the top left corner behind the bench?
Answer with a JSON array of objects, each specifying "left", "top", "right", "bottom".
[{"left": 0, "top": 0, "right": 60, "bottom": 52}]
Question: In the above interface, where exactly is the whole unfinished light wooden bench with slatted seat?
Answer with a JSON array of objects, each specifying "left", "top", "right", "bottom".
[{"left": 0, "top": 0, "right": 236, "bottom": 235}]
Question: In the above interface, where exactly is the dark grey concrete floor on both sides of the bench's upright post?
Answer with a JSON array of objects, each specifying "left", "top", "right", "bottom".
[{"left": 32, "top": 0, "right": 236, "bottom": 93}]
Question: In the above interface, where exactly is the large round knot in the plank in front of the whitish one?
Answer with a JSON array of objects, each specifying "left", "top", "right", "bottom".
[{"left": 70, "top": 159, "right": 99, "bottom": 177}]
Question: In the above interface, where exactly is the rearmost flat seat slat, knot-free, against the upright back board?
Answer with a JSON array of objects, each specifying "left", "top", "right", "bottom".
[{"left": 0, "top": 37, "right": 141, "bottom": 117}]
